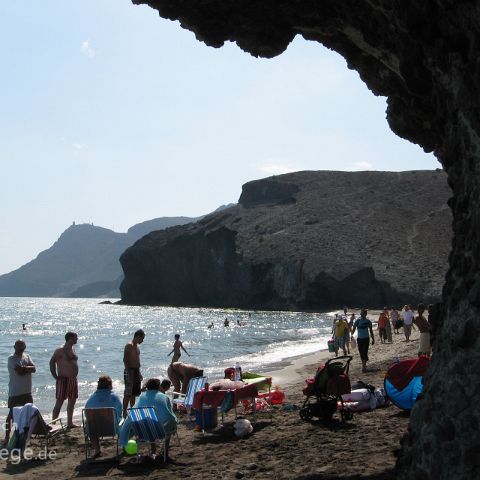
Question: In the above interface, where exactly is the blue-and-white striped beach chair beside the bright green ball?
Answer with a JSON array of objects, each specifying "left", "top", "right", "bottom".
[{"left": 128, "top": 407, "right": 169, "bottom": 462}]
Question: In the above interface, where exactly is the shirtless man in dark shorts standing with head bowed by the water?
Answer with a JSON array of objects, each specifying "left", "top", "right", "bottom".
[{"left": 123, "top": 330, "right": 145, "bottom": 417}]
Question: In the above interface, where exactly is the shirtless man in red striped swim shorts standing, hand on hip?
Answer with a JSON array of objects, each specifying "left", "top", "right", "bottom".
[{"left": 50, "top": 332, "right": 78, "bottom": 428}]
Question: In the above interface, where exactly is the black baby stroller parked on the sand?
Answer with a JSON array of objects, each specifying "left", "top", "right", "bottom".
[{"left": 299, "top": 355, "right": 353, "bottom": 423}]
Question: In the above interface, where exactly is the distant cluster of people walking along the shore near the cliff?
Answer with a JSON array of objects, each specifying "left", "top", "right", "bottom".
[{"left": 332, "top": 303, "right": 433, "bottom": 372}]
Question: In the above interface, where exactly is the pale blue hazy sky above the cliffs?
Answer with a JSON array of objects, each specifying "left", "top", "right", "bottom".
[{"left": 0, "top": 0, "right": 440, "bottom": 274}]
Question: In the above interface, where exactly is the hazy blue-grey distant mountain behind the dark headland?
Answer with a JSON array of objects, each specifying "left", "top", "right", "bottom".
[{"left": 0, "top": 212, "right": 211, "bottom": 297}]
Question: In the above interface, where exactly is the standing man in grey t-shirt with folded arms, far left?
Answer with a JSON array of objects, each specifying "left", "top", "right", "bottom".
[{"left": 3, "top": 338, "right": 36, "bottom": 446}]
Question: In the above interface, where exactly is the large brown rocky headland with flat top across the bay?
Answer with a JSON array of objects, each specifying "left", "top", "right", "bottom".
[{"left": 120, "top": 170, "right": 451, "bottom": 309}]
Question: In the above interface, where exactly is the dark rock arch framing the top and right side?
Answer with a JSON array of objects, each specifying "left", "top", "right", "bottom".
[{"left": 132, "top": 0, "right": 480, "bottom": 479}]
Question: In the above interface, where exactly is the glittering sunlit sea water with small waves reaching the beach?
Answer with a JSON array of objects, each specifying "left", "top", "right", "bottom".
[{"left": 0, "top": 297, "right": 338, "bottom": 420}]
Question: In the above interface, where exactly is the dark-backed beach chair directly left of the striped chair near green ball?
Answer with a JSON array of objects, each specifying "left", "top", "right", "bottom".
[{"left": 82, "top": 407, "right": 120, "bottom": 460}]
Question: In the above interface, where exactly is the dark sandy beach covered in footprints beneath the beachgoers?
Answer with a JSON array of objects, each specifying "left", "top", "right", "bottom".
[{"left": 0, "top": 315, "right": 419, "bottom": 480}]
